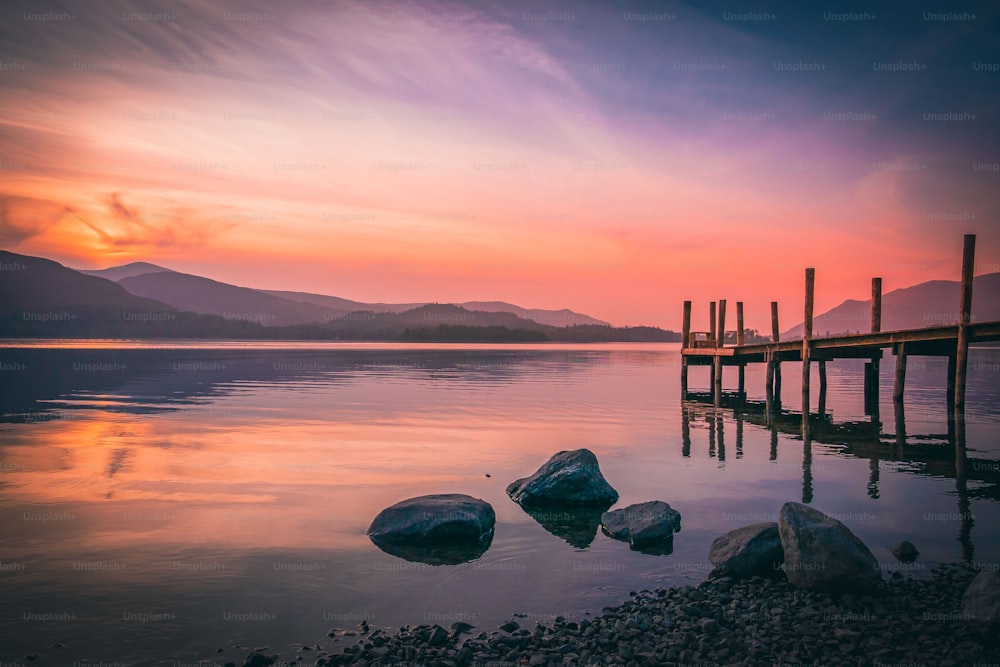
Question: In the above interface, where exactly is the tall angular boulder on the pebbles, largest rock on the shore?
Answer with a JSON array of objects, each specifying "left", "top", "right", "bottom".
[{"left": 778, "top": 503, "right": 882, "bottom": 594}]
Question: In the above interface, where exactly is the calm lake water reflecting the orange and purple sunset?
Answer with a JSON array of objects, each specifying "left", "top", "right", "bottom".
[{"left": 0, "top": 342, "right": 1000, "bottom": 665}]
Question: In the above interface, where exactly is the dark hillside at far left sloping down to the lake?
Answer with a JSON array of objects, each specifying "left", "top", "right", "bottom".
[{"left": 0, "top": 251, "right": 259, "bottom": 338}]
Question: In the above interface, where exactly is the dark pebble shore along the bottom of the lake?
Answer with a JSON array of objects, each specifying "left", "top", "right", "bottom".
[{"left": 238, "top": 565, "right": 1000, "bottom": 667}]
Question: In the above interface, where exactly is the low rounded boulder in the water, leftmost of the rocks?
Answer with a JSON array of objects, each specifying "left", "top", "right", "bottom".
[{"left": 368, "top": 493, "right": 496, "bottom": 564}]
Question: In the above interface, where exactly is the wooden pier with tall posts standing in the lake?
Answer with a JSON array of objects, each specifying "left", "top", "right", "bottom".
[{"left": 681, "top": 234, "right": 1000, "bottom": 440}]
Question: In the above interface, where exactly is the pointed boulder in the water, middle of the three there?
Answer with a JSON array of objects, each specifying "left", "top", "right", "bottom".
[{"left": 507, "top": 449, "right": 618, "bottom": 508}]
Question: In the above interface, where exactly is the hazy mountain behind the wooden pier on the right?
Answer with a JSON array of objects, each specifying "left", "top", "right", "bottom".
[{"left": 781, "top": 273, "right": 1000, "bottom": 340}]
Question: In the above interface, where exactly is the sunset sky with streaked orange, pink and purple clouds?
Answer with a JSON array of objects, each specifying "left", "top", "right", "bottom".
[{"left": 0, "top": 0, "right": 1000, "bottom": 330}]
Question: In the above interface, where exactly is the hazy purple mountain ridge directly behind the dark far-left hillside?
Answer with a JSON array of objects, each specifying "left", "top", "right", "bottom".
[{"left": 118, "top": 271, "right": 340, "bottom": 327}]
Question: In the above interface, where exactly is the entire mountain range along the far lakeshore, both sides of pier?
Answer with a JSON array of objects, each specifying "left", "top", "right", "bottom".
[{"left": 7, "top": 251, "right": 1000, "bottom": 342}]
